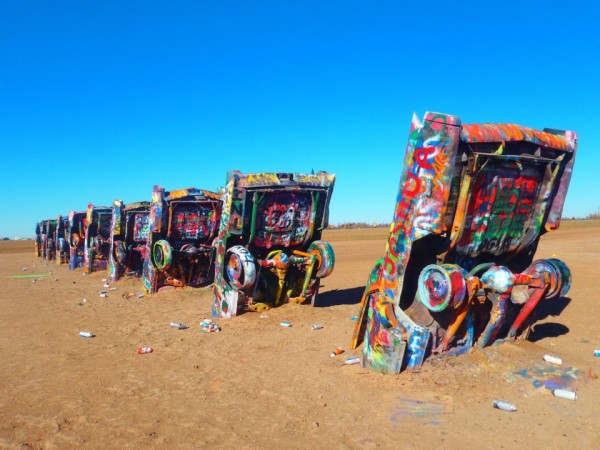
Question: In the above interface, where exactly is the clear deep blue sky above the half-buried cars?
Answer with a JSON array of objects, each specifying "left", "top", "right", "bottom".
[{"left": 0, "top": 0, "right": 600, "bottom": 238}]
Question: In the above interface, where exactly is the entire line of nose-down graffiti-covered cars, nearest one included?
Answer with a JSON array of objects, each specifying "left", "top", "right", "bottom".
[{"left": 32, "top": 112, "right": 577, "bottom": 373}]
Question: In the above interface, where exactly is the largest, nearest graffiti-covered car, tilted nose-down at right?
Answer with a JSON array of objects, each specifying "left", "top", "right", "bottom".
[{"left": 352, "top": 113, "right": 577, "bottom": 373}]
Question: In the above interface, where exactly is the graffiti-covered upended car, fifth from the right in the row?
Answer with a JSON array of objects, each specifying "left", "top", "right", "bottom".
[{"left": 83, "top": 203, "right": 112, "bottom": 273}]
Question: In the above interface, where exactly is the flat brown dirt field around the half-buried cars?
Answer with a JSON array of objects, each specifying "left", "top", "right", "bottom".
[{"left": 0, "top": 221, "right": 600, "bottom": 449}]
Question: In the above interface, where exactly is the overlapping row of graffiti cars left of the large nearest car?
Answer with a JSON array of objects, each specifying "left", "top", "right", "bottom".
[{"left": 35, "top": 171, "right": 335, "bottom": 317}]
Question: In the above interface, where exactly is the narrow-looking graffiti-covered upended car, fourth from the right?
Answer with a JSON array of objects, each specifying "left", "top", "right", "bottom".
[{"left": 109, "top": 200, "right": 150, "bottom": 281}]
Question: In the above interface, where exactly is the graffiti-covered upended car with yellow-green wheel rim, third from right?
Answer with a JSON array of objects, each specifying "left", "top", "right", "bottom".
[{"left": 142, "top": 186, "right": 223, "bottom": 294}]
